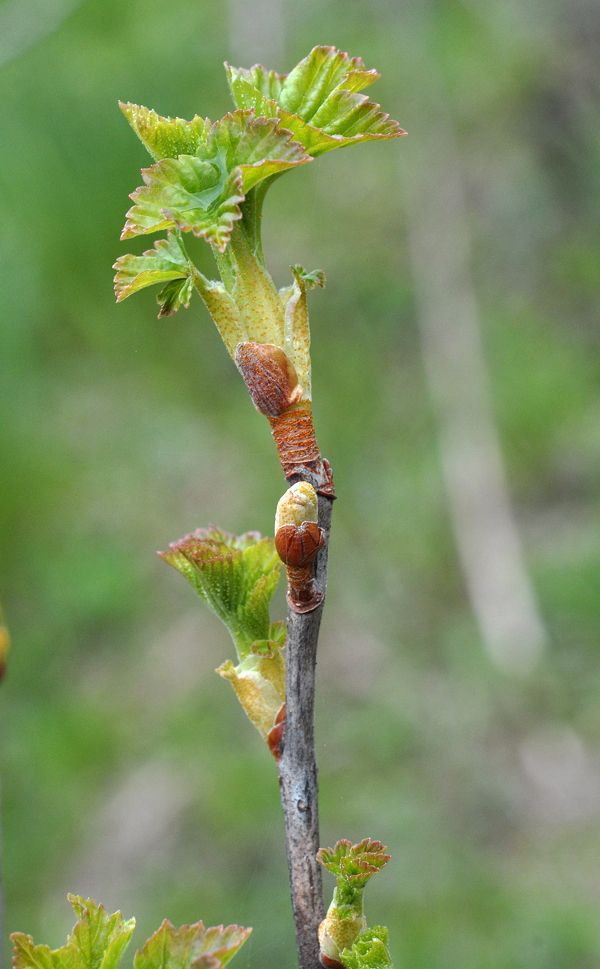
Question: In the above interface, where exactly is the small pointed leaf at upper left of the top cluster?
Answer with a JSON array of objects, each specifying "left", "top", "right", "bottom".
[{"left": 119, "top": 101, "right": 211, "bottom": 161}]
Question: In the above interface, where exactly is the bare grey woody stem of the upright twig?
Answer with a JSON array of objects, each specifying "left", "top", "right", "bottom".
[{"left": 279, "top": 496, "right": 333, "bottom": 969}]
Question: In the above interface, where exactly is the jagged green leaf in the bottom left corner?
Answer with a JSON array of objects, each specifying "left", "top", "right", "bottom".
[{"left": 10, "top": 895, "right": 135, "bottom": 969}]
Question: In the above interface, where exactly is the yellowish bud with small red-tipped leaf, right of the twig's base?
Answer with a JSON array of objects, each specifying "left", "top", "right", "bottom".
[{"left": 317, "top": 838, "right": 390, "bottom": 969}]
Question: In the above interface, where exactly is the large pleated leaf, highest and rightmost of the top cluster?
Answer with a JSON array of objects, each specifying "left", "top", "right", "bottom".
[{"left": 225, "top": 46, "right": 406, "bottom": 156}]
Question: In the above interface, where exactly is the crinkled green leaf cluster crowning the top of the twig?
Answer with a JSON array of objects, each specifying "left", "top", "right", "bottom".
[{"left": 114, "top": 46, "right": 405, "bottom": 318}]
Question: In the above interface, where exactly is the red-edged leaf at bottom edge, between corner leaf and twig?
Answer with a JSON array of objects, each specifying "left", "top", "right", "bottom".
[{"left": 133, "top": 919, "right": 252, "bottom": 969}]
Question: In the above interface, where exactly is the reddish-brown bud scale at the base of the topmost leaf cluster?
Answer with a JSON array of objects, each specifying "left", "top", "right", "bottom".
[{"left": 235, "top": 342, "right": 302, "bottom": 417}]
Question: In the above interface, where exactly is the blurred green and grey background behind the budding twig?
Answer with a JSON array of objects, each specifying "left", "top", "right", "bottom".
[{"left": 0, "top": 0, "right": 600, "bottom": 969}]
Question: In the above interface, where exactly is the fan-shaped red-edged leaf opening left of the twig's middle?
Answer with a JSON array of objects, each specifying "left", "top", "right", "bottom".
[{"left": 159, "top": 528, "right": 281, "bottom": 660}]
